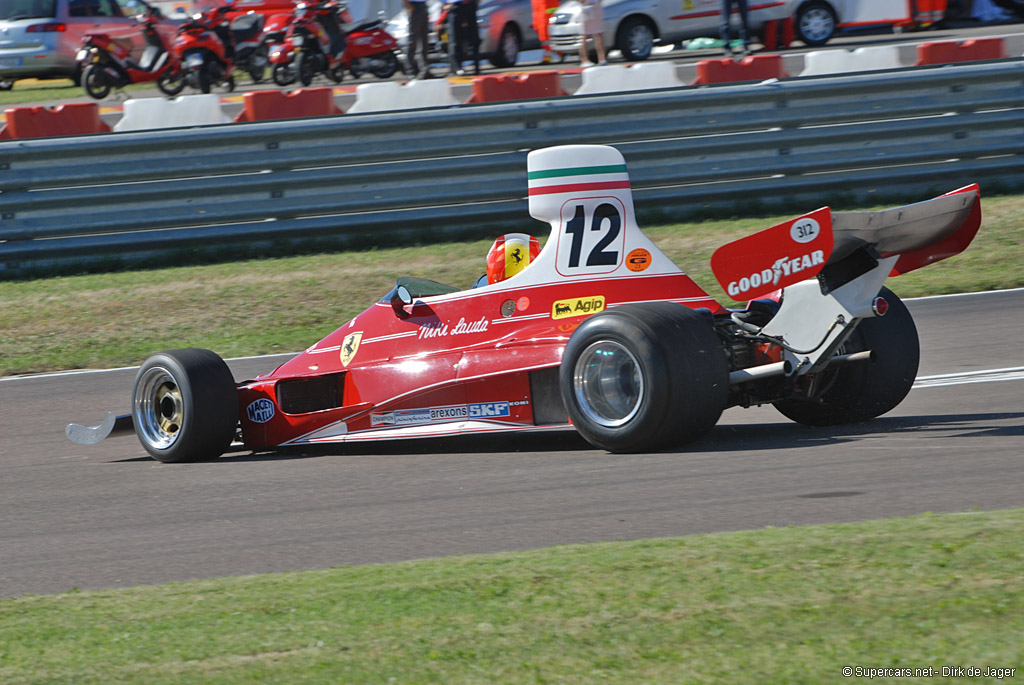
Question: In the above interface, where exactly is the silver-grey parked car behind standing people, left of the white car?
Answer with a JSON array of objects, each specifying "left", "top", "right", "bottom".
[{"left": 387, "top": 0, "right": 541, "bottom": 68}]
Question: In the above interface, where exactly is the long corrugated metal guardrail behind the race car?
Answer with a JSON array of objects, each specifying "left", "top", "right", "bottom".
[{"left": 0, "top": 59, "right": 1024, "bottom": 275}]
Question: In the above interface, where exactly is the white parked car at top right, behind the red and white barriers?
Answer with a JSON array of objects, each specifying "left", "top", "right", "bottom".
[{"left": 549, "top": 0, "right": 792, "bottom": 61}]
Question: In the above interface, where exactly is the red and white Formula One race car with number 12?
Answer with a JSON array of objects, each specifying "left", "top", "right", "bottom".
[{"left": 68, "top": 145, "right": 981, "bottom": 462}]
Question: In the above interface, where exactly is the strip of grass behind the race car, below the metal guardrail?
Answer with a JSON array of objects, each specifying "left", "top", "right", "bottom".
[{"left": 0, "top": 191, "right": 1024, "bottom": 375}]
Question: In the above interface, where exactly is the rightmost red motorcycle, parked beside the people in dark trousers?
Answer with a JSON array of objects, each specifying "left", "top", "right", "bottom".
[{"left": 270, "top": 2, "right": 404, "bottom": 86}]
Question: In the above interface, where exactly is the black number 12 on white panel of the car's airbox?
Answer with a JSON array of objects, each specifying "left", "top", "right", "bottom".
[{"left": 556, "top": 198, "right": 625, "bottom": 275}]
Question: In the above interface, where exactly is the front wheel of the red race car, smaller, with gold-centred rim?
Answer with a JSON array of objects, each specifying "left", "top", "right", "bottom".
[{"left": 132, "top": 348, "right": 239, "bottom": 464}]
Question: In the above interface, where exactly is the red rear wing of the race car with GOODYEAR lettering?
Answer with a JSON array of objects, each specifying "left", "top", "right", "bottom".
[{"left": 711, "top": 184, "right": 981, "bottom": 300}]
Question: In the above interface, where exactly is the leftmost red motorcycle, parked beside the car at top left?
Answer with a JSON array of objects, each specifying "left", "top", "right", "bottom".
[{"left": 75, "top": 3, "right": 185, "bottom": 100}]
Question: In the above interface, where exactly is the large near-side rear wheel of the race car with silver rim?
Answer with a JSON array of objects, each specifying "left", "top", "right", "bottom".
[{"left": 559, "top": 302, "right": 729, "bottom": 453}]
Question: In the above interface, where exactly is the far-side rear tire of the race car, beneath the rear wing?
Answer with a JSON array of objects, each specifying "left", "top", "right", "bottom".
[{"left": 775, "top": 288, "right": 921, "bottom": 426}]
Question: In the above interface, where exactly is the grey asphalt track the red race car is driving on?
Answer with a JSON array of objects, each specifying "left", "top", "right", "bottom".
[{"left": 0, "top": 280, "right": 1024, "bottom": 596}]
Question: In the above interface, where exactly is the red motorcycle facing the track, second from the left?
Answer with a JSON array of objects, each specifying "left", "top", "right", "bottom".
[{"left": 173, "top": 5, "right": 234, "bottom": 93}]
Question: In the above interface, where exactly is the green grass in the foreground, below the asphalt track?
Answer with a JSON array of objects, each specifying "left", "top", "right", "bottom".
[{"left": 0, "top": 509, "right": 1024, "bottom": 685}]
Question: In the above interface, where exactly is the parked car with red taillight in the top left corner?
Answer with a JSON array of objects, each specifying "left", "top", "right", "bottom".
[{"left": 0, "top": 0, "right": 175, "bottom": 90}]
